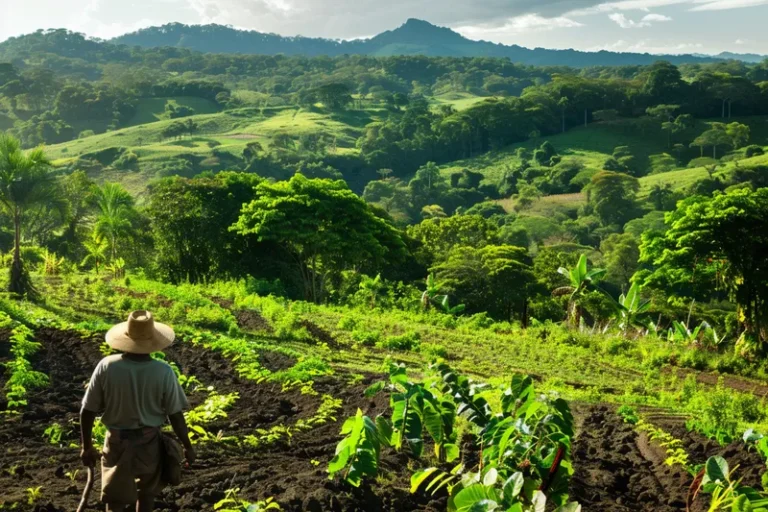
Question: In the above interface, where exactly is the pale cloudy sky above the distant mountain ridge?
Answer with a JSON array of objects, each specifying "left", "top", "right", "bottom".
[{"left": 0, "top": 0, "right": 768, "bottom": 54}]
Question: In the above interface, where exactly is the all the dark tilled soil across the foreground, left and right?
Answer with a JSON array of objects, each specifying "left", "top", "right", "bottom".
[{"left": 0, "top": 329, "right": 765, "bottom": 512}]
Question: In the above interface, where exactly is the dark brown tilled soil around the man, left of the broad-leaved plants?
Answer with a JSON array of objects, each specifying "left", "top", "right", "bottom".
[{"left": 0, "top": 329, "right": 445, "bottom": 512}]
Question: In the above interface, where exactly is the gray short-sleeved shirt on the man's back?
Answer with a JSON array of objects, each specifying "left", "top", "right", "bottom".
[{"left": 83, "top": 354, "right": 189, "bottom": 429}]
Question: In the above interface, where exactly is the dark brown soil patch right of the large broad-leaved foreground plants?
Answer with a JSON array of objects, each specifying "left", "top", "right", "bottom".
[{"left": 571, "top": 405, "right": 765, "bottom": 512}]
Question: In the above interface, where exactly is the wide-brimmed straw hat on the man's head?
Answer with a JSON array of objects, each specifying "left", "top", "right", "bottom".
[{"left": 107, "top": 311, "right": 176, "bottom": 354}]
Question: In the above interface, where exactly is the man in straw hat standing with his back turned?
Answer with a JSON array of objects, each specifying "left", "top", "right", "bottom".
[{"left": 80, "top": 311, "right": 195, "bottom": 512}]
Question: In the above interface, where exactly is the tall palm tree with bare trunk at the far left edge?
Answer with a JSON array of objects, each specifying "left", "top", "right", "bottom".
[{"left": 0, "top": 135, "right": 57, "bottom": 296}]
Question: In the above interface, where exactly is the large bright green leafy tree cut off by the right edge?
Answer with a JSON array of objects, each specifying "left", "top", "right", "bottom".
[{"left": 638, "top": 188, "right": 768, "bottom": 351}]
